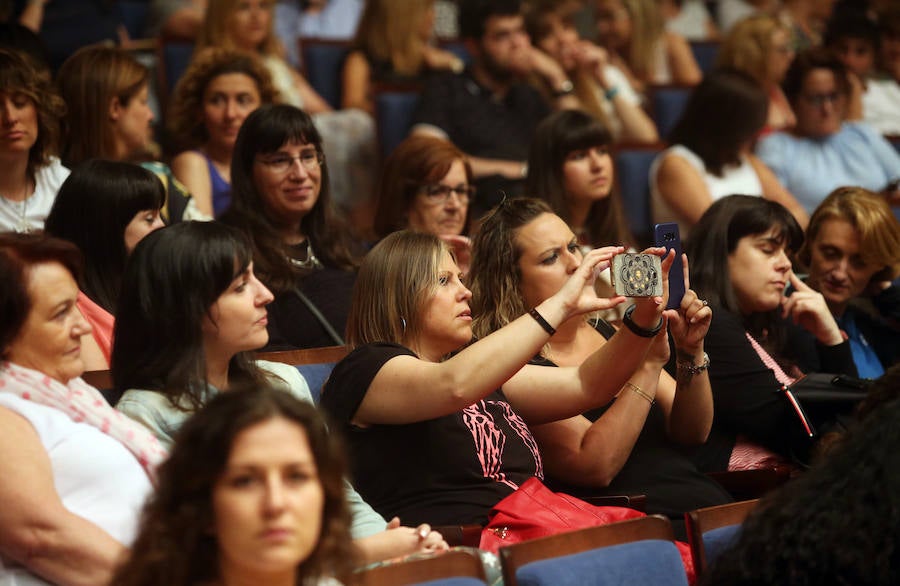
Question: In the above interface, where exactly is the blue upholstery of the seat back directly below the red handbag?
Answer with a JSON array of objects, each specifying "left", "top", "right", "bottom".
[{"left": 516, "top": 539, "right": 688, "bottom": 586}]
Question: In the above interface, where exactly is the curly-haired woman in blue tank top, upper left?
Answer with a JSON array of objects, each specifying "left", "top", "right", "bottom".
[{"left": 167, "top": 47, "right": 278, "bottom": 216}]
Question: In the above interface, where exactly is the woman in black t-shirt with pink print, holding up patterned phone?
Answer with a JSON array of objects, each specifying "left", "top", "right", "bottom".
[{"left": 321, "top": 230, "right": 674, "bottom": 525}]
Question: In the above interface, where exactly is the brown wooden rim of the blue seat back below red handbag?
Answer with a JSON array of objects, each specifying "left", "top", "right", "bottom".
[{"left": 500, "top": 515, "right": 687, "bottom": 586}]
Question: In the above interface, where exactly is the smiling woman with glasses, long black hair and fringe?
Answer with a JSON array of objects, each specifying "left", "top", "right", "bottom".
[{"left": 221, "top": 104, "right": 357, "bottom": 349}]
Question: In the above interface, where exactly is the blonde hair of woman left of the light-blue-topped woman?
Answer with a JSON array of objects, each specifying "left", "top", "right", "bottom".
[{"left": 716, "top": 14, "right": 787, "bottom": 87}]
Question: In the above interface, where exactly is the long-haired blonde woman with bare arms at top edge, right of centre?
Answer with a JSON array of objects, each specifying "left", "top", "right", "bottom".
[{"left": 595, "top": 0, "right": 703, "bottom": 90}]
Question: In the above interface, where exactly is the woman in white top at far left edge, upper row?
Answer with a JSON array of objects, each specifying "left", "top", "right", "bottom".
[{"left": 0, "top": 49, "right": 69, "bottom": 232}]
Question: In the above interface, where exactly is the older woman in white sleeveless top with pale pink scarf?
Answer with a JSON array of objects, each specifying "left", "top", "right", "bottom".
[{"left": 0, "top": 233, "right": 165, "bottom": 586}]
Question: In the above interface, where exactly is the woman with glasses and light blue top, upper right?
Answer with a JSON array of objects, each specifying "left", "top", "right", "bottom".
[{"left": 756, "top": 49, "right": 900, "bottom": 213}]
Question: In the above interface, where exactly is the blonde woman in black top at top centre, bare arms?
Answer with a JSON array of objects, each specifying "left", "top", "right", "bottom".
[{"left": 341, "top": 0, "right": 464, "bottom": 113}]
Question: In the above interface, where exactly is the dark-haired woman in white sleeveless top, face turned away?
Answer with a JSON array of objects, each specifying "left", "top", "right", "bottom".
[{"left": 650, "top": 70, "right": 809, "bottom": 234}]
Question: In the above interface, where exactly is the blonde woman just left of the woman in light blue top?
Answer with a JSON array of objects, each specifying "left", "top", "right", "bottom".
[{"left": 716, "top": 14, "right": 797, "bottom": 133}]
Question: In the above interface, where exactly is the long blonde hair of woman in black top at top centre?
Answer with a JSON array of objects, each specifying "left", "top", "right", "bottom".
[{"left": 354, "top": 0, "right": 434, "bottom": 75}]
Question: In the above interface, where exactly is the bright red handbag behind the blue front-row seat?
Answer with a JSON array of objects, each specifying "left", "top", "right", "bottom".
[{"left": 479, "top": 478, "right": 695, "bottom": 584}]
